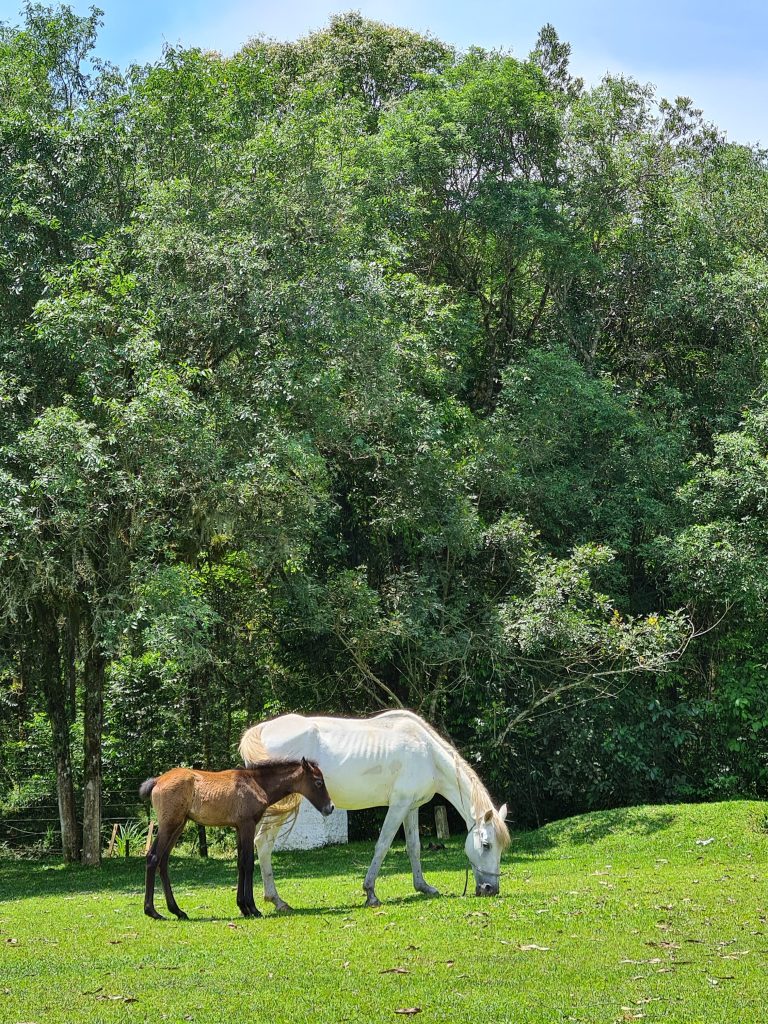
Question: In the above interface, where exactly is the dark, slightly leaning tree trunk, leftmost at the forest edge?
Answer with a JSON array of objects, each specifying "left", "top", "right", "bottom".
[{"left": 35, "top": 606, "right": 80, "bottom": 862}]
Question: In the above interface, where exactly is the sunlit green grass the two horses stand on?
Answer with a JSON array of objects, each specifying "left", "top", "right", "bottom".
[{"left": 0, "top": 802, "right": 768, "bottom": 1024}]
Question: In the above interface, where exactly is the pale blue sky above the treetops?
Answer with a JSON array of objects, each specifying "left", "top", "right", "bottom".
[{"left": 0, "top": 0, "right": 768, "bottom": 146}]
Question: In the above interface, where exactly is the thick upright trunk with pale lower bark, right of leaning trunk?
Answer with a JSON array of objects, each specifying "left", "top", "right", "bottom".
[{"left": 83, "top": 630, "right": 105, "bottom": 866}]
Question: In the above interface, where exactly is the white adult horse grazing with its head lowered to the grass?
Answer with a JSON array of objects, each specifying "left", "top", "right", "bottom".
[{"left": 240, "top": 711, "right": 510, "bottom": 910}]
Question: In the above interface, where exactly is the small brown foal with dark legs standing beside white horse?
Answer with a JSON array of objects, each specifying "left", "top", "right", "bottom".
[{"left": 139, "top": 758, "right": 334, "bottom": 921}]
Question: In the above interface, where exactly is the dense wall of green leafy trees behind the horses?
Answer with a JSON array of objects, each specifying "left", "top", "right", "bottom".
[{"left": 0, "top": 4, "right": 768, "bottom": 863}]
